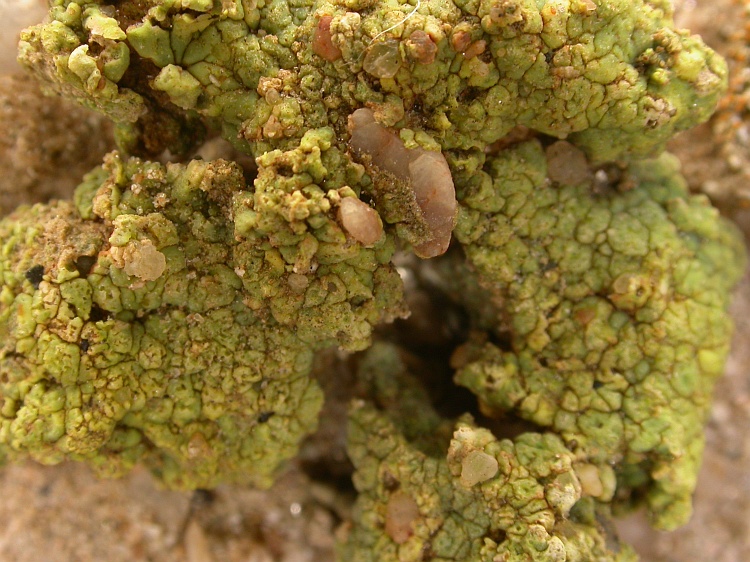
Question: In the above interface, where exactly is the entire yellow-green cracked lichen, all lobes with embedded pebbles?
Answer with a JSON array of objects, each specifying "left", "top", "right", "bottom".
[{"left": 0, "top": 0, "right": 744, "bottom": 562}]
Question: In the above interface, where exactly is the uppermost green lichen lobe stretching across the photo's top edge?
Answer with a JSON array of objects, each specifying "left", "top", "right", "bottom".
[{"left": 20, "top": 0, "right": 726, "bottom": 161}]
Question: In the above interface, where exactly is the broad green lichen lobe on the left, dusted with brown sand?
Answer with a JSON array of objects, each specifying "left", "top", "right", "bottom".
[{"left": 0, "top": 138, "right": 401, "bottom": 488}]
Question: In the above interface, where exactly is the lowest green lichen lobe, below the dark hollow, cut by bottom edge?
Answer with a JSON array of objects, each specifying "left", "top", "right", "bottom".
[{"left": 338, "top": 344, "right": 636, "bottom": 562}]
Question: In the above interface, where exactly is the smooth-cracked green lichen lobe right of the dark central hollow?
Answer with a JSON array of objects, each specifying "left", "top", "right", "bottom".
[{"left": 455, "top": 141, "right": 744, "bottom": 528}]
